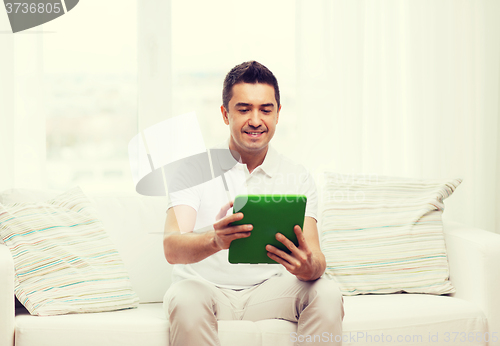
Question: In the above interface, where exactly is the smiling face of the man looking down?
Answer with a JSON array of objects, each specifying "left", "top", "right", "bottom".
[{"left": 221, "top": 83, "right": 281, "bottom": 155}]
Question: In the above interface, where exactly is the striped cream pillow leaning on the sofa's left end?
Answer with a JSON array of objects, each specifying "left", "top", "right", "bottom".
[{"left": 0, "top": 188, "right": 139, "bottom": 316}]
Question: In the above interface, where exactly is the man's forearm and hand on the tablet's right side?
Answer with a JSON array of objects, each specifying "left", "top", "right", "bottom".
[{"left": 266, "top": 216, "right": 326, "bottom": 281}]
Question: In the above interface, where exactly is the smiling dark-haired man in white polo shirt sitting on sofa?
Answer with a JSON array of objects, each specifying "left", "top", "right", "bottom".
[{"left": 164, "top": 61, "right": 344, "bottom": 346}]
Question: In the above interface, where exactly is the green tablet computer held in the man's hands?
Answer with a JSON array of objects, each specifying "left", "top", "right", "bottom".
[{"left": 228, "top": 195, "right": 307, "bottom": 264}]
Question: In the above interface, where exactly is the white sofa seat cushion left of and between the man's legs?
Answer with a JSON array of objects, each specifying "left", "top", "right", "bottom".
[{"left": 16, "top": 303, "right": 261, "bottom": 346}]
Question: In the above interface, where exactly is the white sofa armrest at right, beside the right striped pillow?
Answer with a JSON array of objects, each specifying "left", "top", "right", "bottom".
[{"left": 444, "top": 222, "right": 500, "bottom": 345}]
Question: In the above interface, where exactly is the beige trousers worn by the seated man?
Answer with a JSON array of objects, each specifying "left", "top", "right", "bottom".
[{"left": 163, "top": 275, "right": 344, "bottom": 346}]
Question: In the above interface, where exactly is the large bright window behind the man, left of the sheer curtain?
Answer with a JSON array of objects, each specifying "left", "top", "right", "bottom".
[{"left": 0, "top": 0, "right": 297, "bottom": 191}]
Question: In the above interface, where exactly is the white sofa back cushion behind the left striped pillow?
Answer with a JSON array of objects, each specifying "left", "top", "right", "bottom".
[{"left": 0, "top": 189, "right": 172, "bottom": 303}]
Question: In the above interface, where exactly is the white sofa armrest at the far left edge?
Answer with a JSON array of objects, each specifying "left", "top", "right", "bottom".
[{"left": 0, "top": 244, "right": 15, "bottom": 346}]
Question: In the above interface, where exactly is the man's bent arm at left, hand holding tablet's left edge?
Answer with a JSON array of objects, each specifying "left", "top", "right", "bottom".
[{"left": 163, "top": 203, "right": 252, "bottom": 264}]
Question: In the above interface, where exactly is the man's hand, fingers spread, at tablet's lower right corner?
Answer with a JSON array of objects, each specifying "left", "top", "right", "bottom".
[{"left": 266, "top": 219, "right": 325, "bottom": 281}]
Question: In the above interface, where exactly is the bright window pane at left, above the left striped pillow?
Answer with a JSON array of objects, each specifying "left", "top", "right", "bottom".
[{"left": 43, "top": 0, "right": 138, "bottom": 191}]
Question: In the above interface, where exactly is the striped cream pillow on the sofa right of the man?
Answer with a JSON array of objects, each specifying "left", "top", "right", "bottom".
[{"left": 321, "top": 173, "right": 462, "bottom": 295}]
